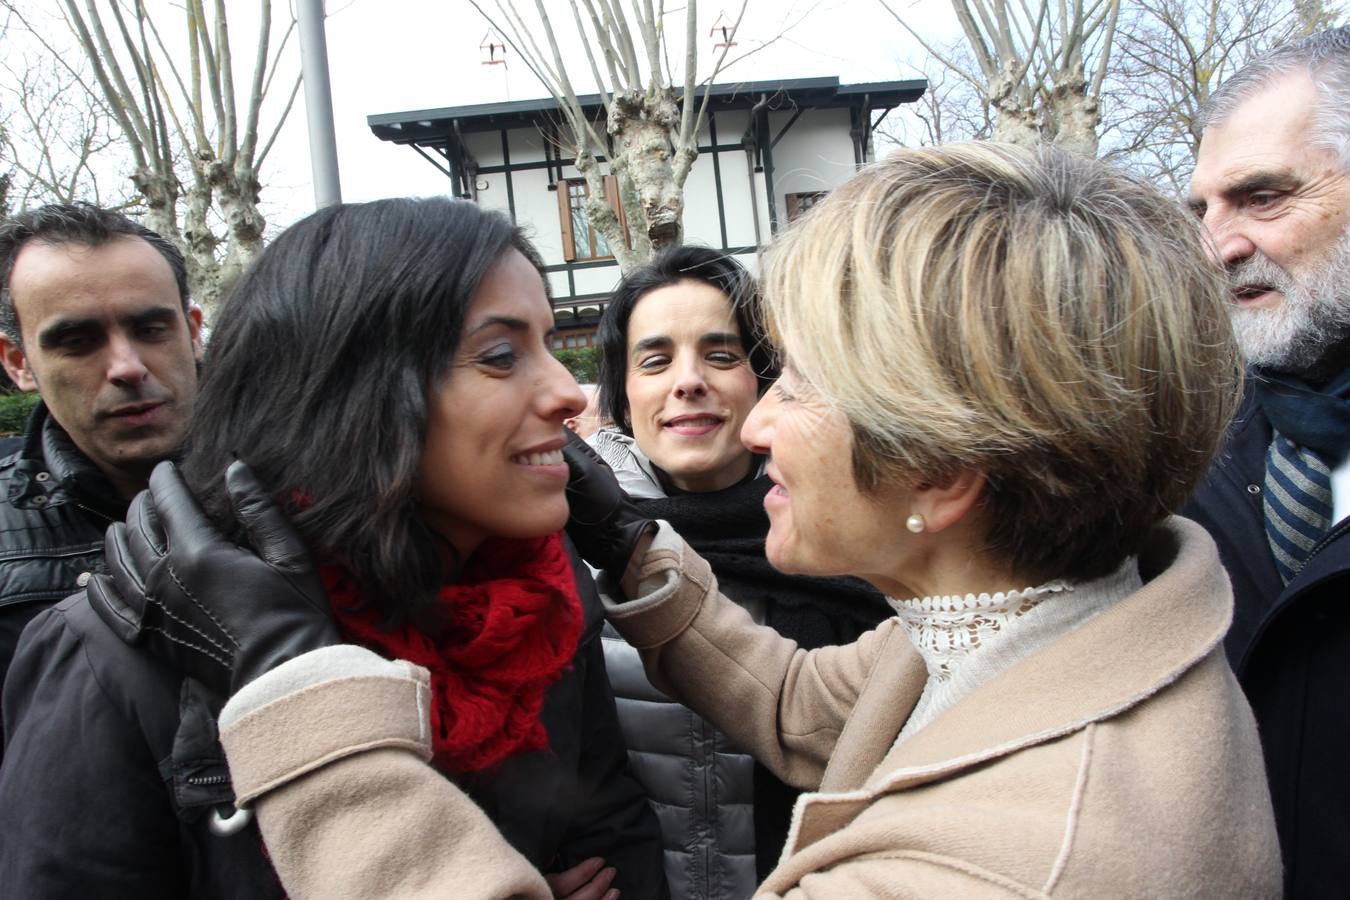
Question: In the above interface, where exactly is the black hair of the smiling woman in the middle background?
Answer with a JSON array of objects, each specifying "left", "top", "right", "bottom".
[{"left": 597, "top": 246, "right": 778, "bottom": 434}]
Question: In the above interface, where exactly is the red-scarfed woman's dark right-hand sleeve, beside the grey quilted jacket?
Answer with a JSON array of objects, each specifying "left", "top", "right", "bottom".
[{"left": 562, "top": 626, "right": 667, "bottom": 900}]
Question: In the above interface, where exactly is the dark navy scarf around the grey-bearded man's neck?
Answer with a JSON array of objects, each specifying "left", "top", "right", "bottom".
[{"left": 1253, "top": 366, "right": 1350, "bottom": 468}]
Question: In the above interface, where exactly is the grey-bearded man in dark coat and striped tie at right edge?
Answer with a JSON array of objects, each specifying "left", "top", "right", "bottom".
[{"left": 1185, "top": 27, "right": 1350, "bottom": 897}]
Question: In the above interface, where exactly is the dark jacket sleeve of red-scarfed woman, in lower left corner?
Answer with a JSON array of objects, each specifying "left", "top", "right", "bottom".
[{"left": 0, "top": 600, "right": 185, "bottom": 900}]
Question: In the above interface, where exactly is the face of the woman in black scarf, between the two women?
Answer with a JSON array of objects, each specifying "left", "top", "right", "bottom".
[{"left": 625, "top": 279, "right": 759, "bottom": 491}]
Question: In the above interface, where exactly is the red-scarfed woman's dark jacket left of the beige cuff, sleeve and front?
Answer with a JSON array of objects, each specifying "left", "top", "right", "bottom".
[{"left": 0, "top": 594, "right": 282, "bottom": 900}]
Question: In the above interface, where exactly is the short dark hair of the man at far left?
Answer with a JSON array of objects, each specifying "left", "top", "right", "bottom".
[{"left": 0, "top": 202, "right": 192, "bottom": 347}]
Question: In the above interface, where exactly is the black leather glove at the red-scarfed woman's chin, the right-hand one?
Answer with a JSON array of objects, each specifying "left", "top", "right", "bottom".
[{"left": 563, "top": 430, "right": 656, "bottom": 584}]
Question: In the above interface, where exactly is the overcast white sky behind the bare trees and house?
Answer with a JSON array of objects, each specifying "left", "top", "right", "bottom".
[{"left": 3, "top": 0, "right": 960, "bottom": 233}]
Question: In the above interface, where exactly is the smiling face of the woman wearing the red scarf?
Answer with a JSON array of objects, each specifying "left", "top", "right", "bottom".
[{"left": 417, "top": 250, "right": 586, "bottom": 559}]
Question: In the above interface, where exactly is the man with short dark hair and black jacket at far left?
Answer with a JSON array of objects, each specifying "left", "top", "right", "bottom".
[{"left": 0, "top": 204, "right": 201, "bottom": 679}]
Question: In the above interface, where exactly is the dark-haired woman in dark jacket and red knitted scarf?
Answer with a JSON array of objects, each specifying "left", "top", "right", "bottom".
[{"left": 0, "top": 198, "right": 666, "bottom": 899}]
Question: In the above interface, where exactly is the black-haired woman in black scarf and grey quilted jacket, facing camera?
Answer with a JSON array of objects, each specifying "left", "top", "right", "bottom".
[{"left": 587, "top": 246, "right": 890, "bottom": 900}]
